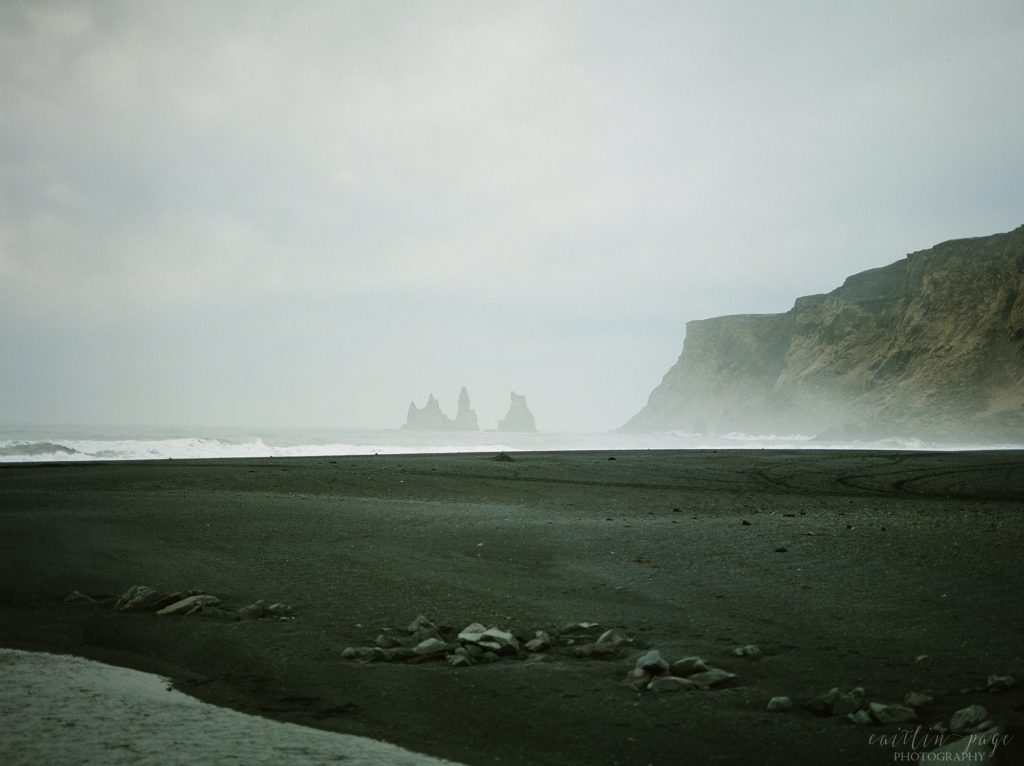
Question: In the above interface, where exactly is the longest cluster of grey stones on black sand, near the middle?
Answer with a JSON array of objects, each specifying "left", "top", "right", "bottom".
[{"left": 341, "top": 614, "right": 634, "bottom": 668}]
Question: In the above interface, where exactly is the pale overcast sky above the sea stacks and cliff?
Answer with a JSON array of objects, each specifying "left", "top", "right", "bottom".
[{"left": 0, "top": 0, "right": 1024, "bottom": 430}]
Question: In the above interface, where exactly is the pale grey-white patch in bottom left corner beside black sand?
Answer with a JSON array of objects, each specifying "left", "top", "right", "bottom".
[{"left": 0, "top": 649, "right": 464, "bottom": 766}]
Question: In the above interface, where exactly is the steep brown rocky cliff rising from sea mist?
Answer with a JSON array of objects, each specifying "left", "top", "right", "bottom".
[{"left": 624, "top": 226, "right": 1024, "bottom": 440}]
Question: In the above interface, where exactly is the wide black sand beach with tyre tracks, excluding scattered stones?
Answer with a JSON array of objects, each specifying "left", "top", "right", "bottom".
[{"left": 0, "top": 452, "right": 1024, "bottom": 766}]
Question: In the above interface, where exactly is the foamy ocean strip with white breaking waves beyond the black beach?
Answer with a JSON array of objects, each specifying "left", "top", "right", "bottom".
[{"left": 0, "top": 425, "right": 1021, "bottom": 463}]
